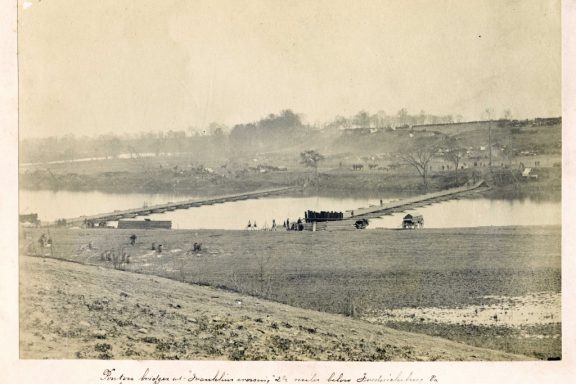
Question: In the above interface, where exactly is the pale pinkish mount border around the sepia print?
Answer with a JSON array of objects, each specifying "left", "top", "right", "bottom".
[{"left": 0, "top": 0, "right": 576, "bottom": 384}]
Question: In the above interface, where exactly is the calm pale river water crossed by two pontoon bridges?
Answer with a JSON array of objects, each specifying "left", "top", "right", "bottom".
[{"left": 20, "top": 190, "right": 561, "bottom": 229}]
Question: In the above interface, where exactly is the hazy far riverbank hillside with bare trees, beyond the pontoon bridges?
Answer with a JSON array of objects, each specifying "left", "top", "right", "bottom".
[{"left": 20, "top": 111, "right": 562, "bottom": 195}]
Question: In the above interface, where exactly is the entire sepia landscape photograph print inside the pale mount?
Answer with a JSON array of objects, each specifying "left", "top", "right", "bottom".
[{"left": 2, "top": 0, "right": 566, "bottom": 382}]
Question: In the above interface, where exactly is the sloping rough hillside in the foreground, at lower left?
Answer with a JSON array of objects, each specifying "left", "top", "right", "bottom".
[{"left": 20, "top": 256, "right": 529, "bottom": 361}]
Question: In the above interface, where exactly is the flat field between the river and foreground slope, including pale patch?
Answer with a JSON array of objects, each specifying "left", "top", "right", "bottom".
[{"left": 21, "top": 226, "right": 561, "bottom": 359}]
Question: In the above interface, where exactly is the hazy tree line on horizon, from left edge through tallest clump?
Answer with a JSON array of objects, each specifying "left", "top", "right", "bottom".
[{"left": 20, "top": 110, "right": 310, "bottom": 163}]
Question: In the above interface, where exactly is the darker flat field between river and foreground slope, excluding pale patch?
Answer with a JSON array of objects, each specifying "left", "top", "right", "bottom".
[{"left": 23, "top": 227, "right": 560, "bottom": 312}]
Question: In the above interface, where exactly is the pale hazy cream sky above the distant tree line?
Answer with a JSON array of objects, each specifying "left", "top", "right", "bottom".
[{"left": 19, "top": 0, "right": 561, "bottom": 137}]
